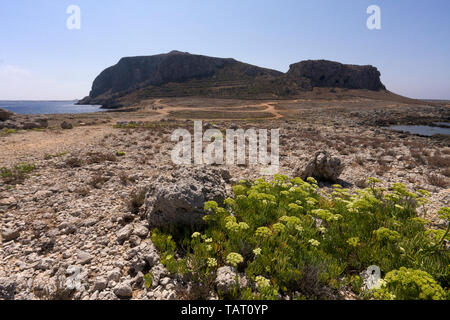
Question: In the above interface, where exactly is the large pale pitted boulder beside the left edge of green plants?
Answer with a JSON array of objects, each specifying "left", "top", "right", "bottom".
[{"left": 145, "top": 167, "right": 227, "bottom": 228}]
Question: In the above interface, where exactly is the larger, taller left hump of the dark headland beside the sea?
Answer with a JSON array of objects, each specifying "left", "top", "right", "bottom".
[{"left": 79, "top": 51, "right": 282, "bottom": 107}]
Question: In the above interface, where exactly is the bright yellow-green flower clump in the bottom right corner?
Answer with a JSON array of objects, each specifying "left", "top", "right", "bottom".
[{"left": 373, "top": 267, "right": 446, "bottom": 300}]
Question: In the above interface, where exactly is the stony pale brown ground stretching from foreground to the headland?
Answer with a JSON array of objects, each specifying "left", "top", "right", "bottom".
[{"left": 0, "top": 99, "right": 450, "bottom": 299}]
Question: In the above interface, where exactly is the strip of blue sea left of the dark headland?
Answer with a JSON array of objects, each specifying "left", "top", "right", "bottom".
[{"left": 0, "top": 100, "right": 104, "bottom": 114}]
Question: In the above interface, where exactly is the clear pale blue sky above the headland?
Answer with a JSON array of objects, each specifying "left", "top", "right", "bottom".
[{"left": 0, "top": 0, "right": 450, "bottom": 100}]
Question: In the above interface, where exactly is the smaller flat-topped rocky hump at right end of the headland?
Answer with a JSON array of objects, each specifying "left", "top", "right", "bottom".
[{"left": 287, "top": 60, "right": 386, "bottom": 90}]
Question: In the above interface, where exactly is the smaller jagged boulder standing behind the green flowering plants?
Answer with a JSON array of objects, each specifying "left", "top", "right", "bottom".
[{"left": 297, "top": 151, "right": 344, "bottom": 182}]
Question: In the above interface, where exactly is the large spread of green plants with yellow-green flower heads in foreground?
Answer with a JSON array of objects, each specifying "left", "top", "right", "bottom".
[{"left": 152, "top": 175, "right": 450, "bottom": 299}]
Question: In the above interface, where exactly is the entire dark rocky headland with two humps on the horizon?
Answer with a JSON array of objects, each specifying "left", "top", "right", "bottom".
[{"left": 79, "top": 51, "right": 385, "bottom": 108}]
